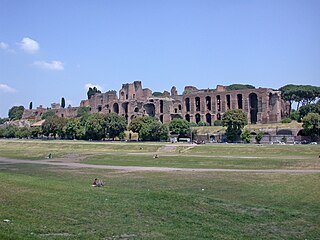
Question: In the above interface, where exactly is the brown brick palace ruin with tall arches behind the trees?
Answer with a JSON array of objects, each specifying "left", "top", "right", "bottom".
[{"left": 23, "top": 81, "right": 286, "bottom": 125}]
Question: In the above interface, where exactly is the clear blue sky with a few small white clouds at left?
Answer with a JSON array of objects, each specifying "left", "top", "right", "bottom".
[{"left": 0, "top": 0, "right": 320, "bottom": 117}]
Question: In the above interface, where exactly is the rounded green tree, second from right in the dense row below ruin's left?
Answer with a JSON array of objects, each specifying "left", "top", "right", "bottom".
[{"left": 84, "top": 113, "right": 106, "bottom": 140}]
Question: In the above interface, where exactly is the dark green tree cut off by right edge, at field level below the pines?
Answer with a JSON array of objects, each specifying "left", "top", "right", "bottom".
[{"left": 302, "top": 113, "right": 320, "bottom": 140}]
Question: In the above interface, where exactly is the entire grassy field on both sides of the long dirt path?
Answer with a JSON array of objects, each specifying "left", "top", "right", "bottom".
[{"left": 0, "top": 141, "right": 320, "bottom": 239}]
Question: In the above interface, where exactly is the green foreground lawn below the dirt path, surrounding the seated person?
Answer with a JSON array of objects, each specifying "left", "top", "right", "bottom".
[{"left": 0, "top": 165, "right": 320, "bottom": 239}]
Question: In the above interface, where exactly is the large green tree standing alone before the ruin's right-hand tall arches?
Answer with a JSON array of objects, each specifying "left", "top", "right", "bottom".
[{"left": 222, "top": 109, "right": 247, "bottom": 142}]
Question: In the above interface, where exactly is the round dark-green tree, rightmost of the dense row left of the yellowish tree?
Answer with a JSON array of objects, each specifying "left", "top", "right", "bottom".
[{"left": 105, "top": 113, "right": 127, "bottom": 139}]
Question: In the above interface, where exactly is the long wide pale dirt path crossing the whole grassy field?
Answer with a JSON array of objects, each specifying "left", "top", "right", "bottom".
[{"left": 0, "top": 157, "right": 320, "bottom": 173}]
